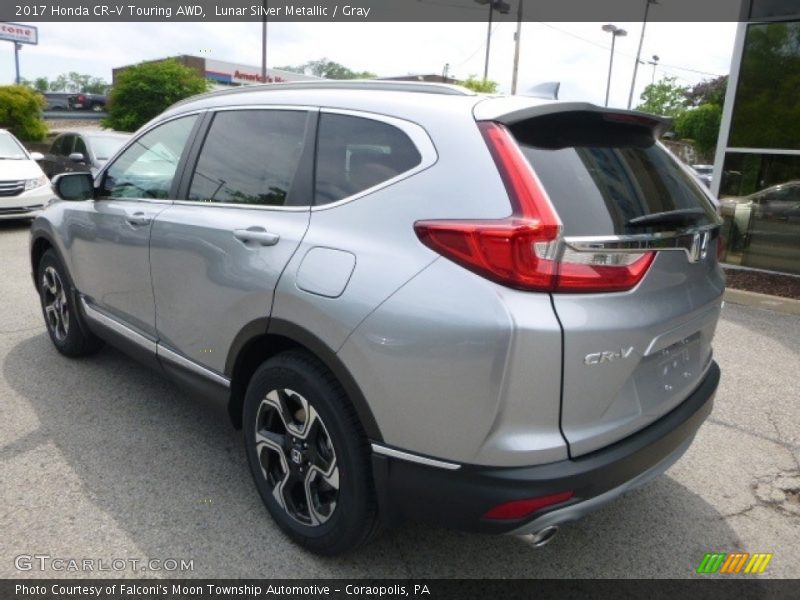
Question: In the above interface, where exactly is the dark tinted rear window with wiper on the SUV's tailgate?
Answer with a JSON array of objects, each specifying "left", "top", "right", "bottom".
[{"left": 512, "top": 115, "right": 716, "bottom": 236}]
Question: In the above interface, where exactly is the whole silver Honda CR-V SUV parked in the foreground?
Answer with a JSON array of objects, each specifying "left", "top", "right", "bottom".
[{"left": 31, "top": 82, "right": 724, "bottom": 554}]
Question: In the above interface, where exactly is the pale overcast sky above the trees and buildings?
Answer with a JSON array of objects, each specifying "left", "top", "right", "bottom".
[{"left": 0, "top": 22, "right": 737, "bottom": 107}]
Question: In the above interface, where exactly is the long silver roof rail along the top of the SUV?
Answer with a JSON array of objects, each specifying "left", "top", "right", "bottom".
[{"left": 173, "top": 79, "right": 475, "bottom": 106}]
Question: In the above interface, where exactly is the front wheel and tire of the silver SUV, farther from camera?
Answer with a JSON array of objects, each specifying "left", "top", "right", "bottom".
[{"left": 36, "top": 250, "right": 103, "bottom": 357}]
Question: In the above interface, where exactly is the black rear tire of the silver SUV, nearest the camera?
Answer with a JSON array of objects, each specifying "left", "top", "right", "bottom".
[{"left": 243, "top": 350, "right": 378, "bottom": 556}]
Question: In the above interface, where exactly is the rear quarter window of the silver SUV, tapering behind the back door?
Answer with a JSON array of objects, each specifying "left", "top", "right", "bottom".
[{"left": 314, "top": 113, "right": 422, "bottom": 204}]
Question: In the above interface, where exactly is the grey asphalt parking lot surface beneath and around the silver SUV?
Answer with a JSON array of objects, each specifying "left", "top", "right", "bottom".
[{"left": 0, "top": 223, "right": 800, "bottom": 578}]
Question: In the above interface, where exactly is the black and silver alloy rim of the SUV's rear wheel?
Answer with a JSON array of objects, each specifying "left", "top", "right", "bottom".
[{"left": 255, "top": 388, "right": 339, "bottom": 527}]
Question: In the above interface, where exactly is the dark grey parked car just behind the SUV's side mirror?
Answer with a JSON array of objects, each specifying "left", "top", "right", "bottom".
[{"left": 40, "top": 130, "right": 130, "bottom": 177}]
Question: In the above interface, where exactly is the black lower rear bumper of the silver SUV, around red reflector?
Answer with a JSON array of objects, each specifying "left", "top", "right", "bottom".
[{"left": 373, "top": 363, "right": 720, "bottom": 534}]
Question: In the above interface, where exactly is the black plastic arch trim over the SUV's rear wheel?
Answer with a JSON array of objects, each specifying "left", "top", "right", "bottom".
[{"left": 225, "top": 318, "right": 383, "bottom": 442}]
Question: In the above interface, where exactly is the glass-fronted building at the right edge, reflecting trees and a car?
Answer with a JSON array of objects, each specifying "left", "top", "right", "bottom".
[{"left": 712, "top": 0, "right": 800, "bottom": 274}]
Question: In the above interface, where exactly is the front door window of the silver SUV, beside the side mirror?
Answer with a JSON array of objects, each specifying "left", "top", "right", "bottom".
[{"left": 103, "top": 115, "right": 197, "bottom": 198}]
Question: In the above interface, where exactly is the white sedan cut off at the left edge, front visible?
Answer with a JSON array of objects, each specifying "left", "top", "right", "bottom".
[{"left": 0, "top": 129, "right": 53, "bottom": 220}]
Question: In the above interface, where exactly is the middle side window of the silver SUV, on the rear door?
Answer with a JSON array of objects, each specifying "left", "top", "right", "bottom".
[{"left": 189, "top": 110, "right": 310, "bottom": 206}]
